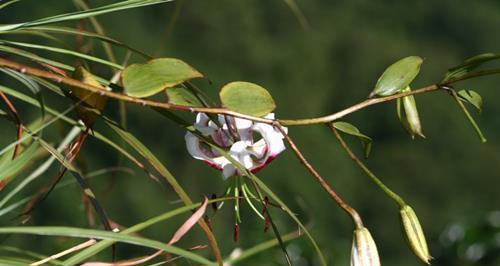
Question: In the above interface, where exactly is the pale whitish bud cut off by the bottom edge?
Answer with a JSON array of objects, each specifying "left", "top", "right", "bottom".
[{"left": 351, "top": 227, "right": 380, "bottom": 266}]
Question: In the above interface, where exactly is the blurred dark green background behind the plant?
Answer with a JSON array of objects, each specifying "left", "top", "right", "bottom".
[{"left": 0, "top": 0, "right": 500, "bottom": 266}]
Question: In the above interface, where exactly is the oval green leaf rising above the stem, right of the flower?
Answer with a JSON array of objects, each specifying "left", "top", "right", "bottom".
[{"left": 370, "top": 56, "right": 423, "bottom": 97}]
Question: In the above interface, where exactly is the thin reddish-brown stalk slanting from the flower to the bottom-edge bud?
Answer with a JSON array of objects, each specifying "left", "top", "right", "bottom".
[{"left": 274, "top": 123, "right": 364, "bottom": 228}]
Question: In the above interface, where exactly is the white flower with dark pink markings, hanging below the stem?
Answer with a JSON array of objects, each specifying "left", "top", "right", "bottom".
[{"left": 185, "top": 113, "right": 287, "bottom": 178}]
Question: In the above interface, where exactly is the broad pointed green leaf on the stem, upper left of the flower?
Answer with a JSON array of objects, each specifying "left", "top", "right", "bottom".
[{"left": 122, "top": 58, "right": 203, "bottom": 98}]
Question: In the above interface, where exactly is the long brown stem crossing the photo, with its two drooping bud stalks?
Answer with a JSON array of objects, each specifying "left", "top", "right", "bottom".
[{"left": 0, "top": 55, "right": 494, "bottom": 228}]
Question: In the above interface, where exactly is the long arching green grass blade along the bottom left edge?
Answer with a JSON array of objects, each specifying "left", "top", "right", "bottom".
[{"left": 0, "top": 226, "right": 214, "bottom": 265}]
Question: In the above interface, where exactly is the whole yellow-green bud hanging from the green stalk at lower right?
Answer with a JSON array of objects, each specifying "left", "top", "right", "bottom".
[{"left": 400, "top": 205, "right": 432, "bottom": 264}]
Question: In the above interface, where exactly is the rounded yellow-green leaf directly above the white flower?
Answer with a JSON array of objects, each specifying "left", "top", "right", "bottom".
[{"left": 219, "top": 81, "right": 276, "bottom": 116}]
